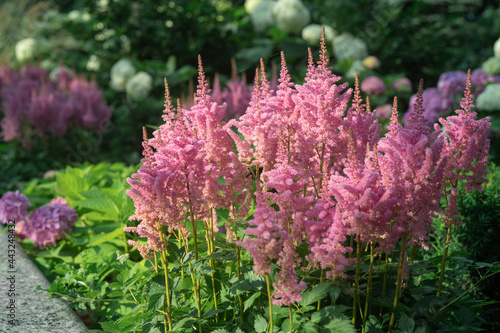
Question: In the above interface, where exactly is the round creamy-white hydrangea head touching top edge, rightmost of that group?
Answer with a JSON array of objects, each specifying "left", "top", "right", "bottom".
[{"left": 273, "top": 0, "right": 311, "bottom": 34}]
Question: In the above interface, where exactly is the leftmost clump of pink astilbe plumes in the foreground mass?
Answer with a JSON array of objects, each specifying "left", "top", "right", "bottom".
[{"left": 125, "top": 59, "right": 248, "bottom": 259}]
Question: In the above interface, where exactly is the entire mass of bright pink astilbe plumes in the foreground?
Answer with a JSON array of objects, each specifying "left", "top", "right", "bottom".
[{"left": 126, "top": 32, "right": 490, "bottom": 305}]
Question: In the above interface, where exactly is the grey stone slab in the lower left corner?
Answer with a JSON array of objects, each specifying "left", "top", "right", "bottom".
[{"left": 0, "top": 225, "right": 89, "bottom": 333}]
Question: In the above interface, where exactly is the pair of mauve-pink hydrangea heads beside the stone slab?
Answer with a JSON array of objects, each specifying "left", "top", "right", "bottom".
[{"left": 0, "top": 191, "right": 78, "bottom": 249}]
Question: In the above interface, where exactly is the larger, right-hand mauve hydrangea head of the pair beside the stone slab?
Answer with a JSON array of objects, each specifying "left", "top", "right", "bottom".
[{"left": 16, "top": 198, "right": 78, "bottom": 249}]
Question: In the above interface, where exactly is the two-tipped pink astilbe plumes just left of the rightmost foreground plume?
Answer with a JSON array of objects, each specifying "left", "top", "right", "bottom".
[{"left": 378, "top": 81, "right": 447, "bottom": 247}]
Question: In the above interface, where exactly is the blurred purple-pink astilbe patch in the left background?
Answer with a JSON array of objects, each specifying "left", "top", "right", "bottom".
[{"left": 0, "top": 66, "right": 111, "bottom": 145}]
